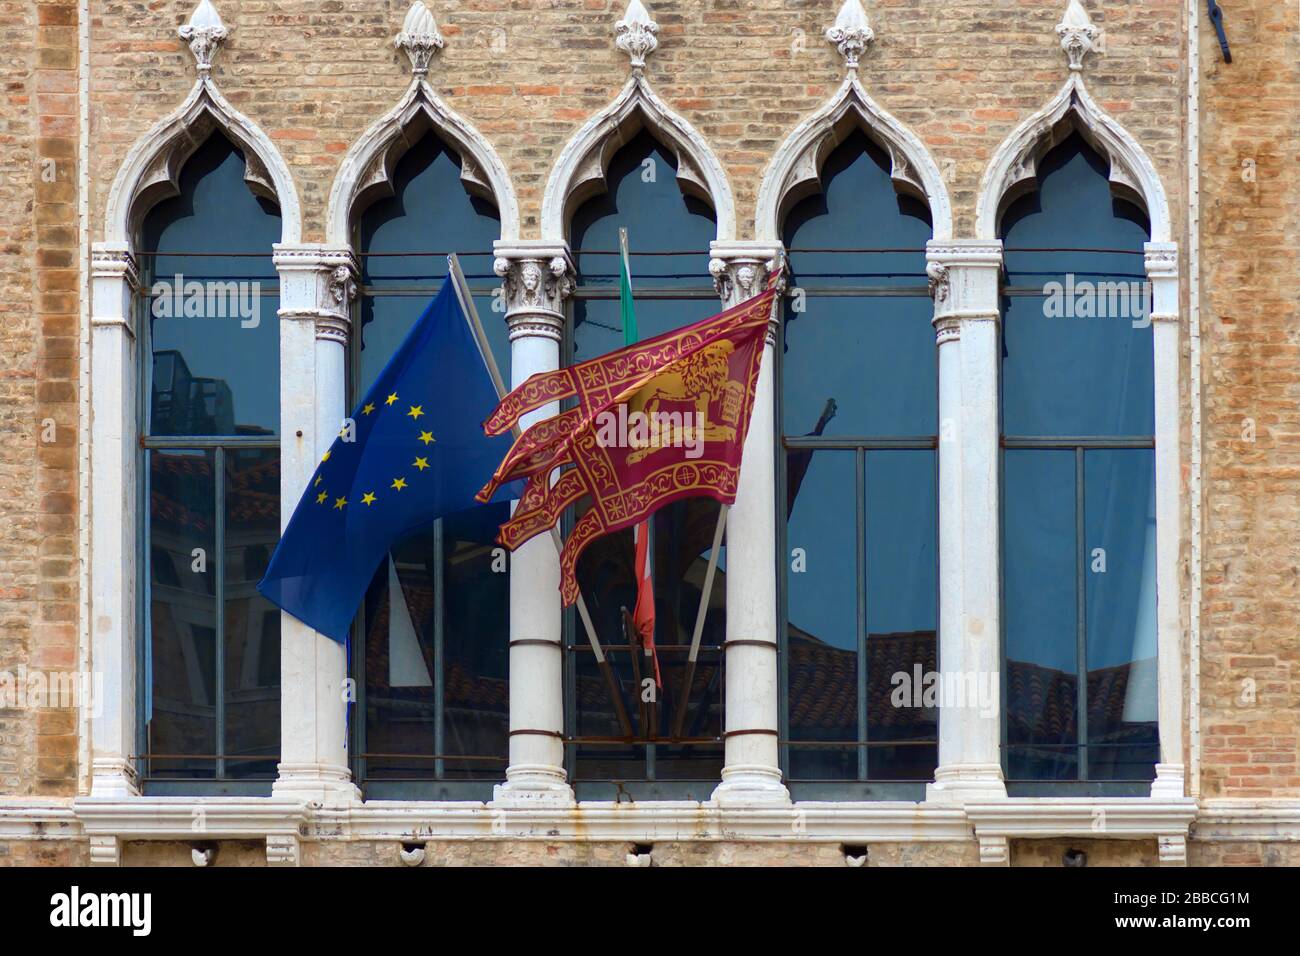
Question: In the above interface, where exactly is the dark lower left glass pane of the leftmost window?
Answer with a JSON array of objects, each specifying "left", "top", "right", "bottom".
[{"left": 146, "top": 451, "right": 217, "bottom": 778}]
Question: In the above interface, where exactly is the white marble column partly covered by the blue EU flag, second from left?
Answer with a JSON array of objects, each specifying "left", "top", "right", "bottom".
[{"left": 272, "top": 243, "right": 360, "bottom": 806}]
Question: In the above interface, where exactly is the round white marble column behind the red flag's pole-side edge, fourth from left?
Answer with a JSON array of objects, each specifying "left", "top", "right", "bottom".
[{"left": 709, "top": 242, "right": 790, "bottom": 806}]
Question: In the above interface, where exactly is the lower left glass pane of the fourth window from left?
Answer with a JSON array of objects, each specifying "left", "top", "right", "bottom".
[{"left": 785, "top": 450, "right": 861, "bottom": 780}]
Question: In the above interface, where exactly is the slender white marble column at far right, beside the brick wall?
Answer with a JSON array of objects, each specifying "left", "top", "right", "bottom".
[{"left": 1145, "top": 242, "right": 1186, "bottom": 801}]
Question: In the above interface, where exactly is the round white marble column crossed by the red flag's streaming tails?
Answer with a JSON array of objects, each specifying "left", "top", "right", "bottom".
[{"left": 484, "top": 241, "right": 573, "bottom": 806}]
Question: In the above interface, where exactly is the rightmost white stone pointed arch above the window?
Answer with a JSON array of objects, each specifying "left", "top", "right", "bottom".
[{"left": 975, "top": 73, "right": 1173, "bottom": 242}]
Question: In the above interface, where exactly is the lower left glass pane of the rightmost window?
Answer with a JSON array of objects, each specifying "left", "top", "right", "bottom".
[{"left": 1002, "top": 449, "right": 1079, "bottom": 779}]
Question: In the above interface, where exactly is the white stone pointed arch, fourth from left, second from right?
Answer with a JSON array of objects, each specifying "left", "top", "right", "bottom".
[{"left": 754, "top": 72, "right": 953, "bottom": 242}]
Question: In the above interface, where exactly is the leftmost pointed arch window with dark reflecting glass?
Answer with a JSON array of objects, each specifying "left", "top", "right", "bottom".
[{"left": 135, "top": 129, "right": 282, "bottom": 792}]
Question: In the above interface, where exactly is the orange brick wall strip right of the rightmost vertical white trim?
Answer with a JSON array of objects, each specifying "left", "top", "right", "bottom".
[{"left": 1201, "top": 0, "right": 1300, "bottom": 797}]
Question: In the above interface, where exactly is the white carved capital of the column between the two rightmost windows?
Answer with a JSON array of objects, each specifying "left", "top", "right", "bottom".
[{"left": 926, "top": 239, "right": 1002, "bottom": 327}]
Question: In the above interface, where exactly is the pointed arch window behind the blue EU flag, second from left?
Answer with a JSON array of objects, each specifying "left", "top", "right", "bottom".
[{"left": 348, "top": 128, "right": 510, "bottom": 799}]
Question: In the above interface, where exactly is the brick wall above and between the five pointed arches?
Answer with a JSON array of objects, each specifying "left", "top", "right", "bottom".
[{"left": 83, "top": 0, "right": 1184, "bottom": 241}]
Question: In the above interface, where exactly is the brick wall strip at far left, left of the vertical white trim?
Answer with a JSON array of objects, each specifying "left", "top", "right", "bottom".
[{"left": 0, "top": 0, "right": 78, "bottom": 795}]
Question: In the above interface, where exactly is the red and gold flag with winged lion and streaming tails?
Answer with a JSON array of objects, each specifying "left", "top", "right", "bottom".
[{"left": 477, "top": 289, "right": 776, "bottom": 605}]
